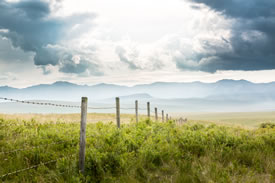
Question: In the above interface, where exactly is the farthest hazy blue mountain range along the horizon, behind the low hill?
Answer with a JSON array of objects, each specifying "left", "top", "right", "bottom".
[{"left": 0, "top": 80, "right": 275, "bottom": 101}]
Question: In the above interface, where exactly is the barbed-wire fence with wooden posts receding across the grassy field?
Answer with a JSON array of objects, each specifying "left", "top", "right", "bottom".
[{"left": 0, "top": 97, "right": 185, "bottom": 178}]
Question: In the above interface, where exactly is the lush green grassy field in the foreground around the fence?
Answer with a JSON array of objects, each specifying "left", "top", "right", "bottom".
[{"left": 0, "top": 114, "right": 275, "bottom": 183}]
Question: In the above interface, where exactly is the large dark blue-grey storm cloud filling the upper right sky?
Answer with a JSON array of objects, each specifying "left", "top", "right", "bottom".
[{"left": 177, "top": 0, "right": 275, "bottom": 72}]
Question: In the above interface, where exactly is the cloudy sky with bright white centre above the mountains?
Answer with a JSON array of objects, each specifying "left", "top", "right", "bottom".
[{"left": 0, "top": 0, "right": 275, "bottom": 87}]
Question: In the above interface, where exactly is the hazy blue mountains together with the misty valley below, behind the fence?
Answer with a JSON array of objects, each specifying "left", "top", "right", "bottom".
[{"left": 0, "top": 80, "right": 275, "bottom": 112}]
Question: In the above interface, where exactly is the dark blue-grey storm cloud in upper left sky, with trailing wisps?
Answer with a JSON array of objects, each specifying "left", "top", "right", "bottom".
[{"left": 0, "top": 0, "right": 97, "bottom": 73}]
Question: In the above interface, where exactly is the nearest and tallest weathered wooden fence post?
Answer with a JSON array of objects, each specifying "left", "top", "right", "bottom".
[{"left": 79, "top": 97, "right": 88, "bottom": 173}]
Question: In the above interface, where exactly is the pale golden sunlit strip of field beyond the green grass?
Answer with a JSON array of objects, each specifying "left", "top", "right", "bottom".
[{"left": 0, "top": 112, "right": 275, "bottom": 129}]
